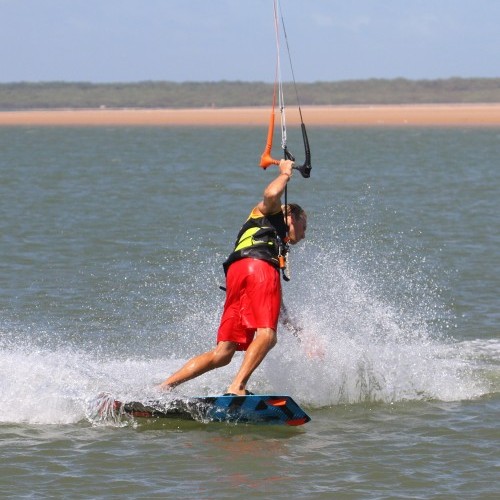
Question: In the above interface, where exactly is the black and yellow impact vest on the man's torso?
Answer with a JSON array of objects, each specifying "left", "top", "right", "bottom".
[{"left": 223, "top": 210, "right": 287, "bottom": 273}]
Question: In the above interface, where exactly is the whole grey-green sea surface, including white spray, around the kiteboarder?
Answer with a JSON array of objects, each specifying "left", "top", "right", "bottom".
[{"left": 0, "top": 125, "right": 500, "bottom": 499}]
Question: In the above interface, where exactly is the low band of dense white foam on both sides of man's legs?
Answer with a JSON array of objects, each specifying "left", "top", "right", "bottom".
[{"left": 0, "top": 332, "right": 494, "bottom": 425}]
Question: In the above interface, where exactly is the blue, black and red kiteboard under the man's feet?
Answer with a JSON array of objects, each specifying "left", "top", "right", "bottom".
[{"left": 114, "top": 394, "right": 311, "bottom": 426}]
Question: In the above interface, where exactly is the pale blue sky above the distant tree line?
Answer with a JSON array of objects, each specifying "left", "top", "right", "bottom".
[{"left": 0, "top": 0, "right": 500, "bottom": 82}]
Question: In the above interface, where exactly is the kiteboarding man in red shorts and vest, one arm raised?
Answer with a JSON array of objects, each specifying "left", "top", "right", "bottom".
[{"left": 160, "top": 160, "right": 307, "bottom": 395}]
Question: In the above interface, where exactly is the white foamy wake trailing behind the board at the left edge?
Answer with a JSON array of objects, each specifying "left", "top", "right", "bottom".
[{"left": 0, "top": 346, "right": 178, "bottom": 424}]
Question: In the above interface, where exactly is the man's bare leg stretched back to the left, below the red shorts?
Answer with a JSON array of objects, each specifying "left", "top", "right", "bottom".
[{"left": 159, "top": 341, "right": 237, "bottom": 390}]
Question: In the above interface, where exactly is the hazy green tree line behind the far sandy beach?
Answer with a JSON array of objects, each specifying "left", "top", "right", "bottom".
[{"left": 0, "top": 78, "right": 500, "bottom": 111}]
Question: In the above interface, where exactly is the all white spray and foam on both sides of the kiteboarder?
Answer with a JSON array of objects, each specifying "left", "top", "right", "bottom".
[{"left": 0, "top": 211, "right": 499, "bottom": 425}]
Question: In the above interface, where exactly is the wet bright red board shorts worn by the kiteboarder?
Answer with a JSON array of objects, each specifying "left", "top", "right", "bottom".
[{"left": 217, "top": 258, "right": 281, "bottom": 351}]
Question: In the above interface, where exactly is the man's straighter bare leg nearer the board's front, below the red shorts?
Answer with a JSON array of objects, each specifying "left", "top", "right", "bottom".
[{"left": 227, "top": 328, "right": 277, "bottom": 395}]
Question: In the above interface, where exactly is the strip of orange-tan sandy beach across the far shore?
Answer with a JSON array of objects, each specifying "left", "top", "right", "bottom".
[{"left": 0, "top": 104, "right": 500, "bottom": 126}]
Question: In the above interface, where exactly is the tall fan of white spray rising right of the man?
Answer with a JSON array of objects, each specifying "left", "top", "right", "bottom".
[{"left": 268, "top": 207, "right": 491, "bottom": 406}]
